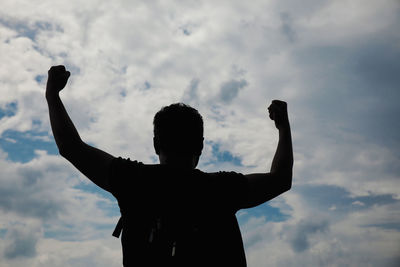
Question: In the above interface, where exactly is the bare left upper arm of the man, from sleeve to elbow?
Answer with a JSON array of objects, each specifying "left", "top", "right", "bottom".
[{"left": 63, "top": 142, "right": 114, "bottom": 191}]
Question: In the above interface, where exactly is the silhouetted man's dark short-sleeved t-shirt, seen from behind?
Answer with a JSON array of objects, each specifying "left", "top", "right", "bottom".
[{"left": 109, "top": 158, "right": 247, "bottom": 267}]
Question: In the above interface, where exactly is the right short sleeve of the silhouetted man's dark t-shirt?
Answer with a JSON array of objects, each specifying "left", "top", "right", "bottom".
[{"left": 213, "top": 172, "right": 248, "bottom": 212}]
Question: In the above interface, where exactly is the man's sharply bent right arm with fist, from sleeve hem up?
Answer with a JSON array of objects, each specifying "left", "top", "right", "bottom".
[{"left": 243, "top": 100, "right": 293, "bottom": 208}]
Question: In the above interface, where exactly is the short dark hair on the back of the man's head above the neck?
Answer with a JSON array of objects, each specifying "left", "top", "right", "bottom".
[{"left": 153, "top": 103, "right": 204, "bottom": 155}]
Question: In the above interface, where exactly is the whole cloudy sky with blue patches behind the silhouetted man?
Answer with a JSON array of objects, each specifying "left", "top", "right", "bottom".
[{"left": 0, "top": 0, "right": 400, "bottom": 267}]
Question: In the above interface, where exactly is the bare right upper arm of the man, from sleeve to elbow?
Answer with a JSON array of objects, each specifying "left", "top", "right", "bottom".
[{"left": 243, "top": 173, "right": 290, "bottom": 208}]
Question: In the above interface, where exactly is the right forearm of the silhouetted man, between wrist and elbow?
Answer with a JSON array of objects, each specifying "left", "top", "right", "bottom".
[{"left": 271, "top": 126, "right": 293, "bottom": 178}]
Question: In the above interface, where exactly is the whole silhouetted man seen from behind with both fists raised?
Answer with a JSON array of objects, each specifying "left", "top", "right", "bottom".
[{"left": 46, "top": 66, "right": 293, "bottom": 267}]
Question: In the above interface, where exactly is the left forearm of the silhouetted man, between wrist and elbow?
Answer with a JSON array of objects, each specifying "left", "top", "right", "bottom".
[{"left": 46, "top": 94, "right": 82, "bottom": 154}]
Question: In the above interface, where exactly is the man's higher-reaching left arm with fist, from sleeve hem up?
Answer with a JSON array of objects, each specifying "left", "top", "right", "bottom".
[{"left": 46, "top": 66, "right": 114, "bottom": 191}]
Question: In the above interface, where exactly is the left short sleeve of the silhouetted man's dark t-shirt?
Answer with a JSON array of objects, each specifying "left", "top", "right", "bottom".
[{"left": 108, "top": 157, "right": 144, "bottom": 199}]
